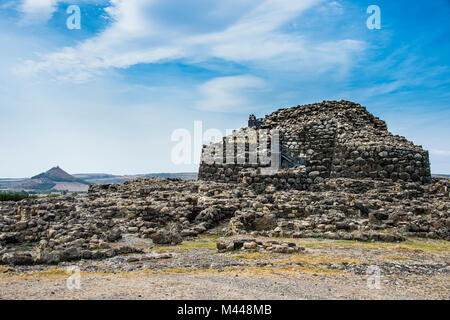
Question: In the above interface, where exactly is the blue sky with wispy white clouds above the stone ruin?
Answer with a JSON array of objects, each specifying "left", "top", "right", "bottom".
[{"left": 0, "top": 0, "right": 450, "bottom": 178}]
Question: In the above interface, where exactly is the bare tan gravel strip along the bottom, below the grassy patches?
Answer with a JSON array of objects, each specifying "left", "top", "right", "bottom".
[{"left": 0, "top": 273, "right": 449, "bottom": 299}]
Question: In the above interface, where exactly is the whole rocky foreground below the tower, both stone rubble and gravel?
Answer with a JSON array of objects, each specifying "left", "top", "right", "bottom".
[{"left": 0, "top": 178, "right": 450, "bottom": 299}]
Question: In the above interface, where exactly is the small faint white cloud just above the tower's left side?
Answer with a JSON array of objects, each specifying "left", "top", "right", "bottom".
[{"left": 196, "top": 75, "right": 266, "bottom": 112}]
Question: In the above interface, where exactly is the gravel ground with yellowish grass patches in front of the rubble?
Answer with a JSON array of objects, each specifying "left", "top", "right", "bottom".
[{"left": 0, "top": 237, "right": 450, "bottom": 300}]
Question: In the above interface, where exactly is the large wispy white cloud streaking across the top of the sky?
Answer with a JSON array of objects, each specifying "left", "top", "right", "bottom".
[{"left": 17, "top": 0, "right": 364, "bottom": 81}]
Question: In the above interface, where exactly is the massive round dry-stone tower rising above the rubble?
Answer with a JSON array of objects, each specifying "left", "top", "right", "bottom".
[{"left": 198, "top": 101, "right": 431, "bottom": 189}]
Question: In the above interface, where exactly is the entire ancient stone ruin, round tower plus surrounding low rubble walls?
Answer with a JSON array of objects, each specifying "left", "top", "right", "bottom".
[{"left": 0, "top": 101, "right": 450, "bottom": 265}]
